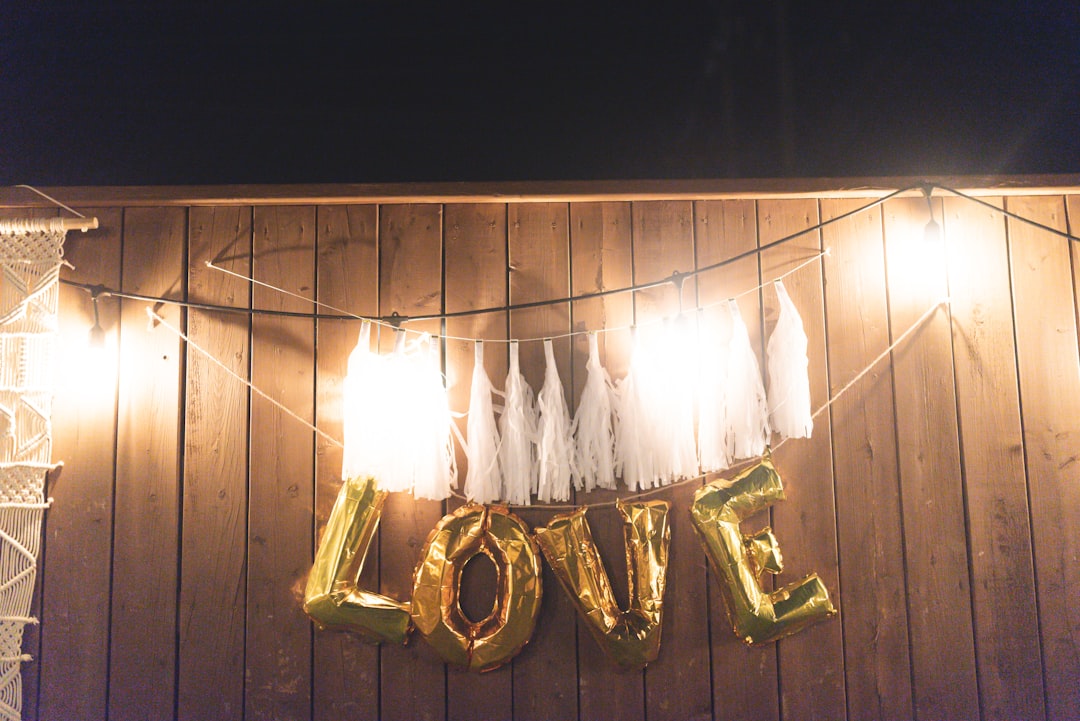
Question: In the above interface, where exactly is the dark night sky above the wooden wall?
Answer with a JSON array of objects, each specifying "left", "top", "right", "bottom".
[{"left": 0, "top": 0, "right": 1080, "bottom": 186}]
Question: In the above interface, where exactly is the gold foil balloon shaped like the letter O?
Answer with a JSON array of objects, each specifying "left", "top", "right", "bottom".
[{"left": 413, "top": 504, "right": 541, "bottom": 671}]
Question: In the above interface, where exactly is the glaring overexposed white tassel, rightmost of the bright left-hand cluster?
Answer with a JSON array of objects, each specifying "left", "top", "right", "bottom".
[{"left": 406, "top": 334, "right": 457, "bottom": 501}]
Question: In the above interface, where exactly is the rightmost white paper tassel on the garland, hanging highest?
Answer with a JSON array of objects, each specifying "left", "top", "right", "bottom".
[{"left": 768, "top": 281, "right": 813, "bottom": 438}]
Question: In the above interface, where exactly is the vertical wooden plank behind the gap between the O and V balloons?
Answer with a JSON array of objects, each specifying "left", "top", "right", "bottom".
[{"left": 507, "top": 203, "right": 578, "bottom": 721}]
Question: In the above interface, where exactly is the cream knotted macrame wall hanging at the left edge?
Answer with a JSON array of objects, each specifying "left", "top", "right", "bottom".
[{"left": 0, "top": 218, "right": 66, "bottom": 721}]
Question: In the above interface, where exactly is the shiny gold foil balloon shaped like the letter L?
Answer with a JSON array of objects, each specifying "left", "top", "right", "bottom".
[{"left": 303, "top": 478, "right": 410, "bottom": 643}]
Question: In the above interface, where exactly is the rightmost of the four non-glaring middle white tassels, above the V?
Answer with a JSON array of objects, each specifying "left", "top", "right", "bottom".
[{"left": 572, "top": 334, "right": 615, "bottom": 491}]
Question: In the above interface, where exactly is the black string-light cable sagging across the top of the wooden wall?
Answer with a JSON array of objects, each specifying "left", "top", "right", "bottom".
[{"left": 60, "top": 186, "right": 920, "bottom": 327}]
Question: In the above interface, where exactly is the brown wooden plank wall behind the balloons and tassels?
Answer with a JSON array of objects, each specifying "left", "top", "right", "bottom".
[{"left": 4, "top": 187, "right": 1080, "bottom": 721}]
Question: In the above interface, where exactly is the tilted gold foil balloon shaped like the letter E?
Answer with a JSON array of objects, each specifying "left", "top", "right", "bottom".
[{"left": 690, "top": 458, "right": 836, "bottom": 643}]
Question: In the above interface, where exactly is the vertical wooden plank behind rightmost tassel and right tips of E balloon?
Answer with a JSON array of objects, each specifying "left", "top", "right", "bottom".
[{"left": 758, "top": 200, "right": 846, "bottom": 719}]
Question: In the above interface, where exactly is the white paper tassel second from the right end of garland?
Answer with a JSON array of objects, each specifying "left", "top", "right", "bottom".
[{"left": 724, "top": 298, "right": 769, "bottom": 459}]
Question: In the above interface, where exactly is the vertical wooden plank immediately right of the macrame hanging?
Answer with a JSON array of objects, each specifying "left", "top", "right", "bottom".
[{"left": 42, "top": 208, "right": 123, "bottom": 720}]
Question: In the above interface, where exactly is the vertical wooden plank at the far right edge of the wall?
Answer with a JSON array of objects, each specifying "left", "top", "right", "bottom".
[{"left": 1006, "top": 195, "right": 1080, "bottom": 720}]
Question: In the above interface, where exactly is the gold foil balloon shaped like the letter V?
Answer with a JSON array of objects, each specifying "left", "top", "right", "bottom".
[{"left": 536, "top": 501, "right": 671, "bottom": 668}]
